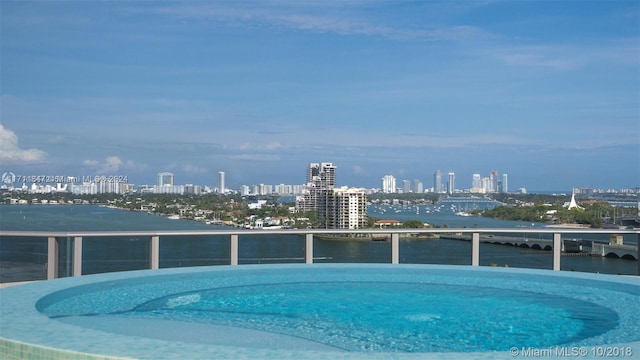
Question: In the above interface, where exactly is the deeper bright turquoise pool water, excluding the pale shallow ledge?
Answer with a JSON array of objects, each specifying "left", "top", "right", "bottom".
[{"left": 126, "top": 282, "right": 617, "bottom": 352}]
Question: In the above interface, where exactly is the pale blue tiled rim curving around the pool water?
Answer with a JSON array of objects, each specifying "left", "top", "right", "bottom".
[{"left": 0, "top": 264, "right": 640, "bottom": 360}]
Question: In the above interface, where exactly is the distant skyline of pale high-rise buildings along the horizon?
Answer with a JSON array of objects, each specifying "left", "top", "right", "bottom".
[{"left": 0, "top": 167, "right": 640, "bottom": 195}]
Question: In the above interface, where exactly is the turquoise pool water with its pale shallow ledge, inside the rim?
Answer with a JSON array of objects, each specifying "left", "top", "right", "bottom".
[{"left": 31, "top": 264, "right": 640, "bottom": 353}]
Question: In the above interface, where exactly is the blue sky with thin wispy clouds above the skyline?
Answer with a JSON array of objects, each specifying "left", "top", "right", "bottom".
[{"left": 0, "top": 0, "right": 640, "bottom": 191}]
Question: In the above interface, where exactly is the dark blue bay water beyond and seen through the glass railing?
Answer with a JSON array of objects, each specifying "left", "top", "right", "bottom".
[{"left": 0, "top": 204, "right": 637, "bottom": 282}]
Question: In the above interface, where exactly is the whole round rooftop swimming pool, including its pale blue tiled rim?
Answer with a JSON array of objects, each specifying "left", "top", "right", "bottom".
[{"left": 0, "top": 264, "right": 640, "bottom": 359}]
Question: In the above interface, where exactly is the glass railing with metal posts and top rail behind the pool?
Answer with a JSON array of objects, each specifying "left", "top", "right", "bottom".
[{"left": 0, "top": 228, "right": 640, "bottom": 282}]
